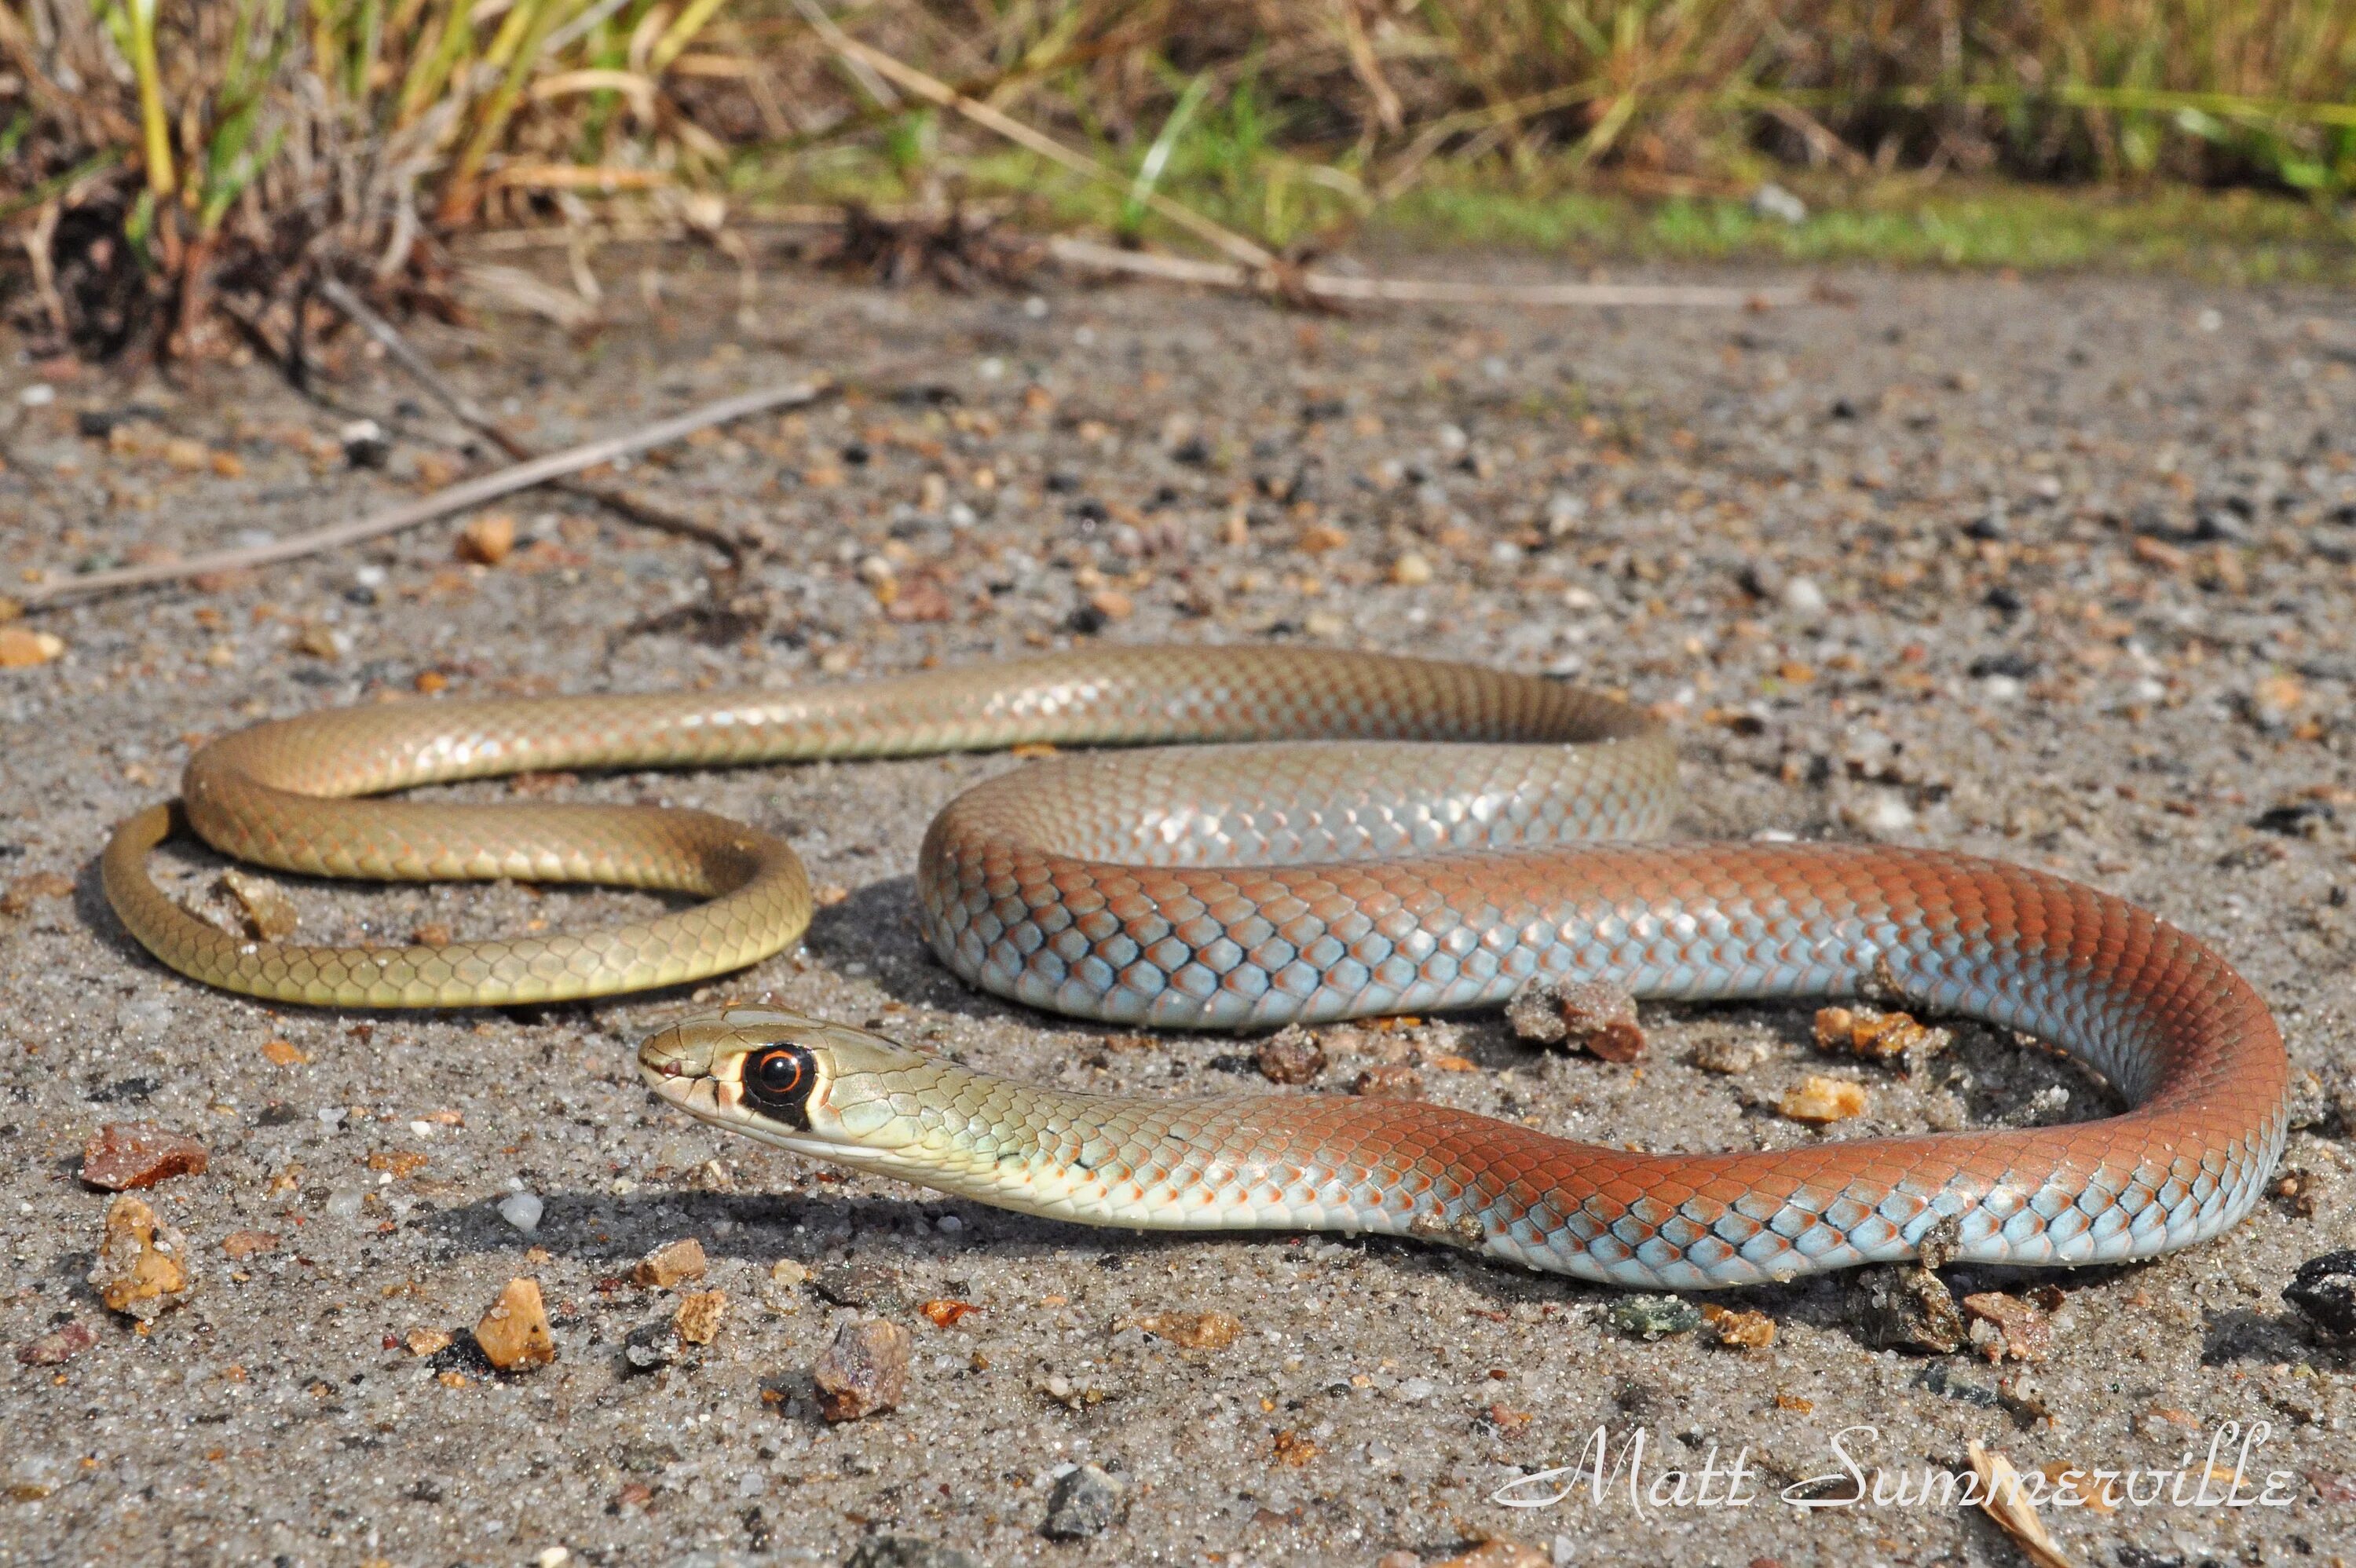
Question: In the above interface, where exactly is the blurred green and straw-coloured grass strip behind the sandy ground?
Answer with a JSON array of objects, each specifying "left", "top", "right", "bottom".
[{"left": 0, "top": 0, "right": 2356, "bottom": 353}]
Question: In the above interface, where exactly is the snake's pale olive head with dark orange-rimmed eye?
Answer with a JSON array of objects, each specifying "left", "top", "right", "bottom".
[{"left": 638, "top": 1007, "right": 938, "bottom": 1168}]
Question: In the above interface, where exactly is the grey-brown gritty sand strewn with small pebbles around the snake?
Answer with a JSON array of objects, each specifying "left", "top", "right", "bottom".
[{"left": 0, "top": 257, "right": 2356, "bottom": 1568}]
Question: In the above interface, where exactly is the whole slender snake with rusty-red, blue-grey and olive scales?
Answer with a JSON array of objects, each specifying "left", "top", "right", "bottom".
[{"left": 101, "top": 645, "right": 2290, "bottom": 1288}]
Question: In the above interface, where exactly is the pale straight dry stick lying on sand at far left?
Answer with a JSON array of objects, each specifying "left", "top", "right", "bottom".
[{"left": 24, "top": 382, "right": 832, "bottom": 608}]
